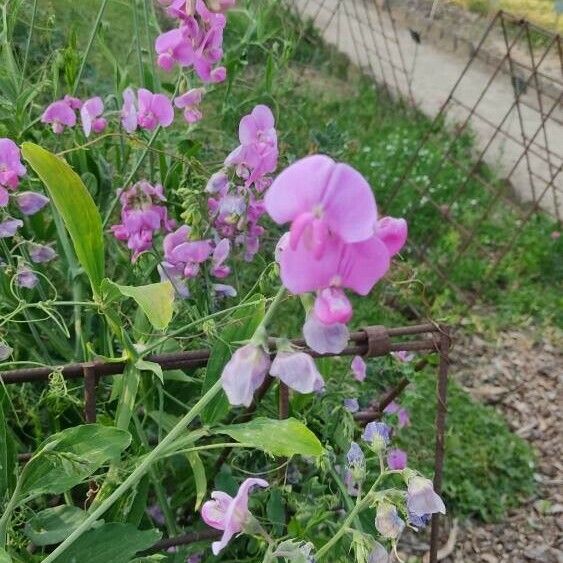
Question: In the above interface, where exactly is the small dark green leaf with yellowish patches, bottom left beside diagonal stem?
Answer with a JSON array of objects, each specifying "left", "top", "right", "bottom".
[{"left": 24, "top": 504, "right": 94, "bottom": 545}]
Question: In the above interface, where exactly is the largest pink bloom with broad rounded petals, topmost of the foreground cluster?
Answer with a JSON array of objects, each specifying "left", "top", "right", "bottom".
[{"left": 265, "top": 155, "right": 377, "bottom": 259}]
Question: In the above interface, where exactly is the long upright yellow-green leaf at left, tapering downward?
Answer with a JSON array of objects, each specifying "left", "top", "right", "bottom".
[{"left": 21, "top": 143, "right": 104, "bottom": 294}]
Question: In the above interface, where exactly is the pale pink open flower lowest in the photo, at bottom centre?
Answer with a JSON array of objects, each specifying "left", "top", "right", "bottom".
[{"left": 201, "top": 478, "right": 268, "bottom": 555}]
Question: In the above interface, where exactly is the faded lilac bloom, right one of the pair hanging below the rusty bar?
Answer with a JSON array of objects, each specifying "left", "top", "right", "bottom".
[{"left": 270, "top": 351, "right": 324, "bottom": 393}]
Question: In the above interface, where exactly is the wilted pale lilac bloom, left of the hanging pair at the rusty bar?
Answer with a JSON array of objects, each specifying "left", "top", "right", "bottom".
[{"left": 221, "top": 343, "right": 270, "bottom": 407}]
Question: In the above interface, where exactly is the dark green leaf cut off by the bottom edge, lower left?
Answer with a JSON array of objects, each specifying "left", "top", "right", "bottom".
[{"left": 57, "top": 522, "right": 162, "bottom": 563}]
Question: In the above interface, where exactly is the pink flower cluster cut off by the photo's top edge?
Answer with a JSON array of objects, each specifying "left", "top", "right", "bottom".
[{"left": 155, "top": 0, "right": 234, "bottom": 83}]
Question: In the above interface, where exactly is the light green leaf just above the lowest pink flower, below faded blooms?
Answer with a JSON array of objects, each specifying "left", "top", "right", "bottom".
[{"left": 212, "top": 417, "right": 324, "bottom": 457}]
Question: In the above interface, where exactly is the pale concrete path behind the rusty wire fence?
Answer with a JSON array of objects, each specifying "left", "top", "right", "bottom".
[{"left": 292, "top": 0, "right": 563, "bottom": 218}]
